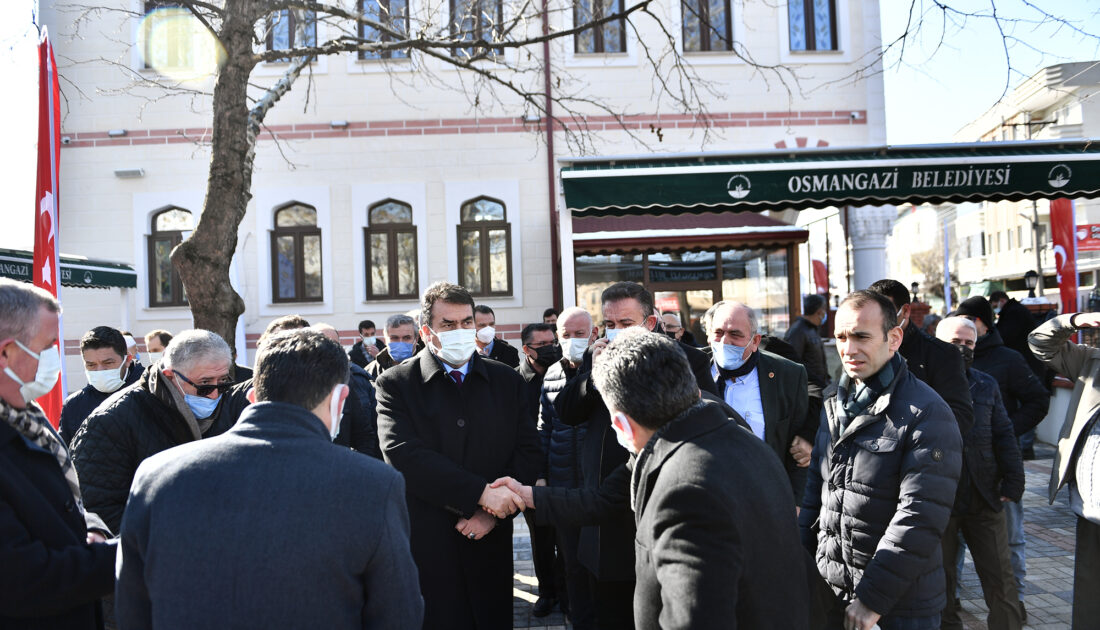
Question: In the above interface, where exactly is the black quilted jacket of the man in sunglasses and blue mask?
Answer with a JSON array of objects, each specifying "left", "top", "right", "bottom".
[{"left": 73, "top": 369, "right": 237, "bottom": 531}]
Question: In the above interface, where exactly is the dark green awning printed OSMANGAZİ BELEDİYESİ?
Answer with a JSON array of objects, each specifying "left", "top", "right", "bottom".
[{"left": 561, "top": 140, "right": 1100, "bottom": 215}]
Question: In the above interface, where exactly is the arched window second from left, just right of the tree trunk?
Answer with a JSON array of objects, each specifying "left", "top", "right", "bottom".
[{"left": 272, "top": 201, "right": 325, "bottom": 302}]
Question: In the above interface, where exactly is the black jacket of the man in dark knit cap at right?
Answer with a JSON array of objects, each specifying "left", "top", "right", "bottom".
[{"left": 974, "top": 328, "right": 1051, "bottom": 435}]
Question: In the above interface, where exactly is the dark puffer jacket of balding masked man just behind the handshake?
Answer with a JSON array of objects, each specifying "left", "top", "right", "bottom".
[{"left": 539, "top": 360, "right": 587, "bottom": 488}]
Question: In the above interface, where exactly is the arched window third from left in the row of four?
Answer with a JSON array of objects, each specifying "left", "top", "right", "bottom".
[{"left": 363, "top": 199, "right": 420, "bottom": 299}]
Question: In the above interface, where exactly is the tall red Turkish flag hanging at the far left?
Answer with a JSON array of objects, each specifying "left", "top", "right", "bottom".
[{"left": 34, "top": 30, "right": 65, "bottom": 429}]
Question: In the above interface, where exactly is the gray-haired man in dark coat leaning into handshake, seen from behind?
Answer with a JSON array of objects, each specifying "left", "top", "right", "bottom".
[{"left": 593, "top": 330, "right": 811, "bottom": 630}]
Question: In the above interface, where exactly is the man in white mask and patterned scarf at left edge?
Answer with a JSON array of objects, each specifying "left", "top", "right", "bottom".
[{"left": 0, "top": 278, "right": 117, "bottom": 630}]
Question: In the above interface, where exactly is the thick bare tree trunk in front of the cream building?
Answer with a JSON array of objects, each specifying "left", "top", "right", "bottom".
[{"left": 172, "top": 0, "right": 256, "bottom": 347}]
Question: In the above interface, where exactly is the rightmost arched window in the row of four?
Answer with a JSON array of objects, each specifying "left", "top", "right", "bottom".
[{"left": 459, "top": 197, "right": 512, "bottom": 297}]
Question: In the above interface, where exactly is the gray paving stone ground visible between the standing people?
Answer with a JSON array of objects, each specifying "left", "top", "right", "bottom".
[{"left": 513, "top": 444, "right": 1077, "bottom": 630}]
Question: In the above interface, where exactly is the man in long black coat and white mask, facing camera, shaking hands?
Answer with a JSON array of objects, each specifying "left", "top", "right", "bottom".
[{"left": 375, "top": 283, "right": 541, "bottom": 630}]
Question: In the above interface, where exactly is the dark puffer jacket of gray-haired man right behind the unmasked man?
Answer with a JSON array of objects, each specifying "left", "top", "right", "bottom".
[{"left": 955, "top": 367, "right": 1024, "bottom": 515}]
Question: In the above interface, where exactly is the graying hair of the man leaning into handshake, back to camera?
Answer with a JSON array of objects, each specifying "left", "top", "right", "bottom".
[{"left": 592, "top": 329, "right": 699, "bottom": 429}]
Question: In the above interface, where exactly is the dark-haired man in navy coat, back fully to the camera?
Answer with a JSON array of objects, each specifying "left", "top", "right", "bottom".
[{"left": 116, "top": 330, "right": 424, "bottom": 630}]
